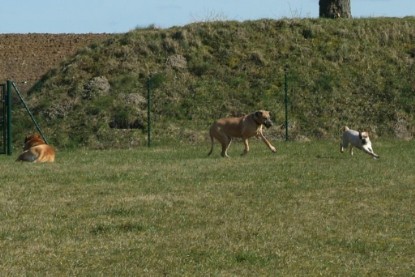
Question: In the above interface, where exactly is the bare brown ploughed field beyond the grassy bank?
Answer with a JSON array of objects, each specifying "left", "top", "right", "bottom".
[{"left": 0, "top": 34, "right": 112, "bottom": 92}]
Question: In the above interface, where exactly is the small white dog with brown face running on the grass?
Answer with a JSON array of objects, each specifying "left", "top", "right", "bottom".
[{"left": 340, "top": 126, "right": 379, "bottom": 159}]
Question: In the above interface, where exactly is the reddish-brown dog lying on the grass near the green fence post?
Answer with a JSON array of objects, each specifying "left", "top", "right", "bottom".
[{"left": 16, "top": 134, "right": 56, "bottom": 163}]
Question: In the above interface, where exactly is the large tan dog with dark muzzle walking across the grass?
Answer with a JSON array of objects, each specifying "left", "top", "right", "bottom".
[{"left": 208, "top": 110, "right": 277, "bottom": 157}]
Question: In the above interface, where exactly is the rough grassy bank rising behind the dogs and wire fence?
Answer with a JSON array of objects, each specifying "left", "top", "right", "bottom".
[{"left": 14, "top": 17, "right": 415, "bottom": 148}]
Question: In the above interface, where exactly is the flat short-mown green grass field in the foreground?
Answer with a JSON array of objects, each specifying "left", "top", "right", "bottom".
[{"left": 0, "top": 140, "right": 415, "bottom": 276}]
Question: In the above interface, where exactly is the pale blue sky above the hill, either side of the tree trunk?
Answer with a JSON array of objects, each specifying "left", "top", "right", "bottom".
[{"left": 0, "top": 0, "right": 415, "bottom": 34}]
